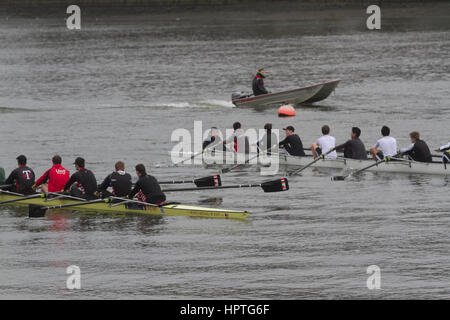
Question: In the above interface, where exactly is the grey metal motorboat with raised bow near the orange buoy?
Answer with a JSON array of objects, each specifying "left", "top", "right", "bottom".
[{"left": 232, "top": 80, "right": 341, "bottom": 108}]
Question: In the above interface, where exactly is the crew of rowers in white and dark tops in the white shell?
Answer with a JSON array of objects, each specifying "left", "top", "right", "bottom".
[{"left": 203, "top": 122, "right": 450, "bottom": 163}]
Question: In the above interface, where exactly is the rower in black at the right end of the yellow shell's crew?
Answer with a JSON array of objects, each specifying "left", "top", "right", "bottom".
[{"left": 128, "top": 164, "right": 166, "bottom": 205}]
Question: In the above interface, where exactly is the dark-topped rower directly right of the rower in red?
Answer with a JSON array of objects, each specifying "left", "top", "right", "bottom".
[{"left": 64, "top": 157, "right": 97, "bottom": 200}]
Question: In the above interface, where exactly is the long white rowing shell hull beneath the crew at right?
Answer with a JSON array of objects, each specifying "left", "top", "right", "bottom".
[{"left": 203, "top": 152, "right": 450, "bottom": 175}]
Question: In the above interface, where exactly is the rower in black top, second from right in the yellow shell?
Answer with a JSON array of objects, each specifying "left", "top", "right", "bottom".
[{"left": 98, "top": 161, "right": 131, "bottom": 198}]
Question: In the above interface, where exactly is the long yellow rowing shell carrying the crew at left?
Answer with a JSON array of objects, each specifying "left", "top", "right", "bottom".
[{"left": 0, "top": 194, "right": 249, "bottom": 220}]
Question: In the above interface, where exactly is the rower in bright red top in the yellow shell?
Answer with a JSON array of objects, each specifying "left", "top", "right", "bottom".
[{"left": 33, "top": 155, "right": 70, "bottom": 193}]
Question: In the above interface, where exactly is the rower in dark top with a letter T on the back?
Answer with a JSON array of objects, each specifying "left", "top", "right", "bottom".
[{"left": 5, "top": 155, "right": 35, "bottom": 194}]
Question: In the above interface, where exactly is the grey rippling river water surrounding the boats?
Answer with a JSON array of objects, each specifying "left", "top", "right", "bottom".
[{"left": 0, "top": 3, "right": 450, "bottom": 299}]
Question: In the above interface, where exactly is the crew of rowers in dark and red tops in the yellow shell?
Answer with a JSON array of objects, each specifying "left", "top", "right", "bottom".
[{"left": 0, "top": 155, "right": 166, "bottom": 205}]
